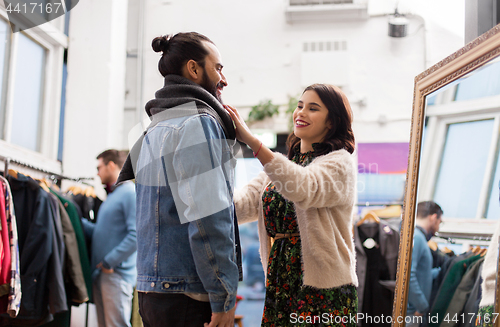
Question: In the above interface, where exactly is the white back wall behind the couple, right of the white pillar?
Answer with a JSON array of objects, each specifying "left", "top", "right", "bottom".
[{"left": 121, "top": 0, "right": 461, "bottom": 142}]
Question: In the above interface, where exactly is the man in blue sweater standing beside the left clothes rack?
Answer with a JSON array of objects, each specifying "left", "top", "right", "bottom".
[{"left": 82, "top": 149, "right": 137, "bottom": 327}]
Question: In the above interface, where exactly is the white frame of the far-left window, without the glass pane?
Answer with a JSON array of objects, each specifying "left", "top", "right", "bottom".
[{"left": 0, "top": 6, "right": 68, "bottom": 173}]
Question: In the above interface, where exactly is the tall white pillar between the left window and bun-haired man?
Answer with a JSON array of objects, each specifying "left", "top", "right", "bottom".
[{"left": 63, "top": 0, "right": 128, "bottom": 184}]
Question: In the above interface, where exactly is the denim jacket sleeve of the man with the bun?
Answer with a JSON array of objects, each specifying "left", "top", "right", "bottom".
[{"left": 172, "top": 115, "right": 239, "bottom": 312}]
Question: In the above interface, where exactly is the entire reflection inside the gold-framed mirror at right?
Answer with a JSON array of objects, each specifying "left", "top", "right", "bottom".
[{"left": 406, "top": 59, "right": 500, "bottom": 326}]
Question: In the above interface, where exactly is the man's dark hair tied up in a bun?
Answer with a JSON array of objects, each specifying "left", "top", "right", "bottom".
[{"left": 151, "top": 32, "right": 213, "bottom": 77}]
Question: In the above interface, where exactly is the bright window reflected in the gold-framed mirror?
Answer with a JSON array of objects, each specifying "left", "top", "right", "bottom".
[{"left": 418, "top": 61, "right": 500, "bottom": 223}]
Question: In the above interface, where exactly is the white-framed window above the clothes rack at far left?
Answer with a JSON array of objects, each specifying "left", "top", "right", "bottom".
[{"left": 0, "top": 9, "right": 67, "bottom": 172}]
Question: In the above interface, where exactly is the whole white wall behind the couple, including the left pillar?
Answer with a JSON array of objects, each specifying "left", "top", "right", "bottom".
[{"left": 58, "top": 0, "right": 463, "bottom": 179}]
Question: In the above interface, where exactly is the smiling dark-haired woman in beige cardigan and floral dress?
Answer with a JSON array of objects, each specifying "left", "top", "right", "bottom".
[{"left": 226, "top": 84, "right": 358, "bottom": 326}]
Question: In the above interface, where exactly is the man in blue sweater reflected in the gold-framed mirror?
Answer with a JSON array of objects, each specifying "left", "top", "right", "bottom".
[{"left": 406, "top": 201, "right": 443, "bottom": 327}]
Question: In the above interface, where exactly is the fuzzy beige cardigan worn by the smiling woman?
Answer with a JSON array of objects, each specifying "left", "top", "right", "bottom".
[{"left": 234, "top": 149, "right": 358, "bottom": 288}]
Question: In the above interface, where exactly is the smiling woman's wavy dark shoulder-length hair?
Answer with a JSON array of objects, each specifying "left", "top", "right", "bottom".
[{"left": 286, "top": 84, "right": 355, "bottom": 159}]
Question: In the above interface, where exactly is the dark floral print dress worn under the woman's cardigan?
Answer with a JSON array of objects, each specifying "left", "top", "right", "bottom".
[{"left": 262, "top": 144, "right": 358, "bottom": 327}]
